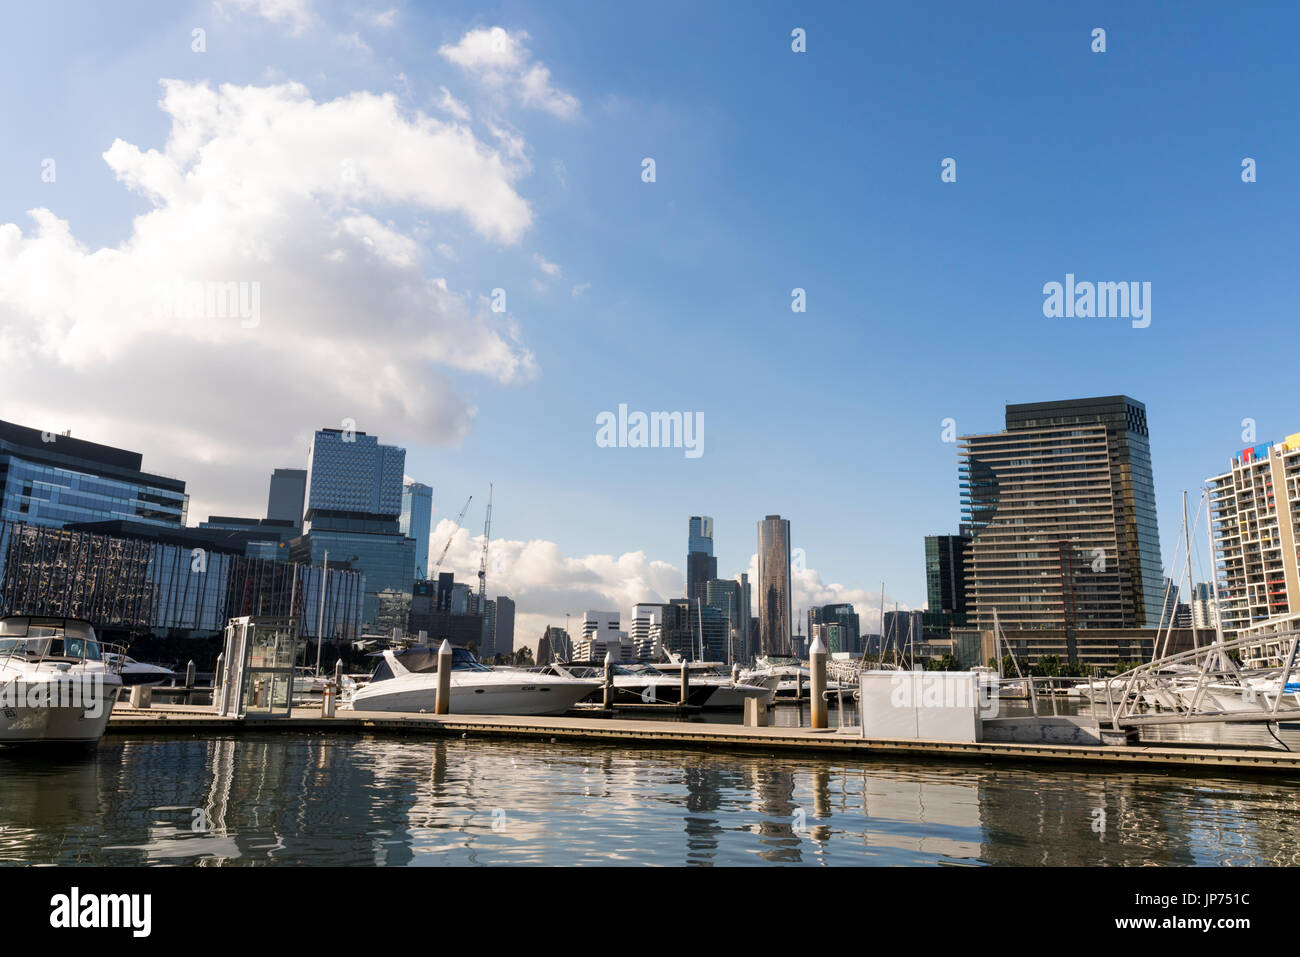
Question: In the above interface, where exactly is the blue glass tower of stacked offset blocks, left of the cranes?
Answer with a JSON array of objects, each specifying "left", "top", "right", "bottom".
[{"left": 290, "top": 429, "right": 416, "bottom": 624}]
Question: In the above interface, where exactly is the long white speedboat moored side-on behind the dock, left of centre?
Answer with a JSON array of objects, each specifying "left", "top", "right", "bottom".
[{"left": 339, "top": 645, "right": 599, "bottom": 715}]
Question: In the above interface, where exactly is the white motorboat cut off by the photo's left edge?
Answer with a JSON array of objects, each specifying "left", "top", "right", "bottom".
[{"left": 0, "top": 615, "right": 122, "bottom": 745}]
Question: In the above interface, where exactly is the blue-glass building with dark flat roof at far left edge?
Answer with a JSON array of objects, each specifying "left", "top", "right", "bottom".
[{"left": 0, "top": 423, "right": 190, "bottom": 528}]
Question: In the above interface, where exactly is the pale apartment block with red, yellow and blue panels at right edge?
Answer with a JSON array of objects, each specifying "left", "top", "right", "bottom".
[{"left": 1193, "top": 433, "right": 1300, "bottom": 632}]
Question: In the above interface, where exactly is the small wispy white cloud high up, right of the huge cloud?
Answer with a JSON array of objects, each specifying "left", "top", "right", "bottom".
[{"left": 438, "top": 26, "right": 582, "bottom": 120}]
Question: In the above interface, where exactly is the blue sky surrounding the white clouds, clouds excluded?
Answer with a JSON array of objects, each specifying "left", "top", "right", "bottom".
[{"left": 0, "top": 0, "right": 1300, "bottom": 634}]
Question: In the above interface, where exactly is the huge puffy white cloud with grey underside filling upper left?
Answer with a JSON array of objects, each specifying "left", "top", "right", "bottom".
[{"left": 0, "top": 81, "right": 536, "bottom": 518}]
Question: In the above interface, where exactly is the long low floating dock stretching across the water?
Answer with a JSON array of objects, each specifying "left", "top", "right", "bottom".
[{"left": 108, "top": 705, "right": 1300, "bottom": 774}]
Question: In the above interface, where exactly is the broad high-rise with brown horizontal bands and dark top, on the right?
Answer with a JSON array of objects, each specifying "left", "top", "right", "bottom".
[{"left": 959, "top": 395, "right": 1164, "bottom": 635}]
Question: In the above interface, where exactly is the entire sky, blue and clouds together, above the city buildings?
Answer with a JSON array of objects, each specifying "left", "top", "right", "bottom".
[{"left": 0, "top": 3, "right": 1300, "bottom": 647}]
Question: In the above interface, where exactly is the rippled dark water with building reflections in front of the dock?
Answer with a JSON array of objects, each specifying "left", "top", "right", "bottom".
[{"left": 0, "top": 735, "right": 1300, "bottom": 865}]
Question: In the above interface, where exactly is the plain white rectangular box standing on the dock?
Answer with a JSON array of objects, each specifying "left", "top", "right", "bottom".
[{"left": 859, "top": 671, "right": 980, "bottom": 741}]
